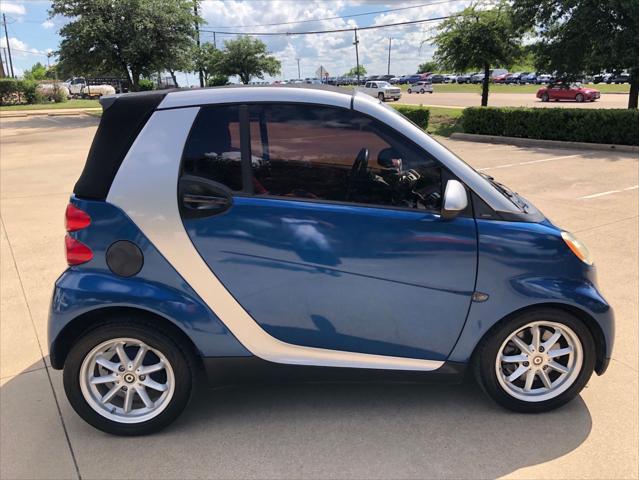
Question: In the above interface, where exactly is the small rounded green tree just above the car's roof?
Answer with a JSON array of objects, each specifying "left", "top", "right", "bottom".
[{"left": 219, "top": 36, "right": 282, "bottom": 83}]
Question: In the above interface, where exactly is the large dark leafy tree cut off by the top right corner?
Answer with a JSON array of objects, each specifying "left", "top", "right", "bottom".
[{"left": 513, "top": 0, "right": 639, "bottom": 108}]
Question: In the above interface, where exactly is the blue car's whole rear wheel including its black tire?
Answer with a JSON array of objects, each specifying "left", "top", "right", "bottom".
[{"left": 63, "top": 318, "right": 196, "bottom": 436}]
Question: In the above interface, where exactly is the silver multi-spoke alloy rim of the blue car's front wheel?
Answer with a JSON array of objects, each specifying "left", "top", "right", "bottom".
[{"left": 495, "top": 321, "right": 583, "bottom": 402}]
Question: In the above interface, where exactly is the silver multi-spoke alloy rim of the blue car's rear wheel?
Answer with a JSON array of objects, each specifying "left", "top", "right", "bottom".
[{"left": 80, "top": 338, "right": 175, "bottom": 423}]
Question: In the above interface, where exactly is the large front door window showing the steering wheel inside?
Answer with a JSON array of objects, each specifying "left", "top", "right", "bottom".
[{"left": 250, "top": 105, "right": 442, "bottom": 210}]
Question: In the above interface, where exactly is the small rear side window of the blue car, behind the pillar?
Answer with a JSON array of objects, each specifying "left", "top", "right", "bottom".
[{"left": 182, "top": 105, "right": 242, "bottom": 191}]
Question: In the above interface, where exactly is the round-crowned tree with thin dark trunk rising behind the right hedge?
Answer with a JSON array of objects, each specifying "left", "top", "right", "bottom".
[{"left": 434, "top": 3, "right": 521, "bottom": 107}]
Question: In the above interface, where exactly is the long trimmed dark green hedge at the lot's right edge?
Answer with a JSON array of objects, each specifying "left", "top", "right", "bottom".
[{"left": 461, "top": 107, "right": 639, "bottom": 145}]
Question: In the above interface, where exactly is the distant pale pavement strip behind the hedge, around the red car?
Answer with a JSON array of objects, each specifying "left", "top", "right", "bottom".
[{"left": 399, "top": 91, "right": 628, "bottom": 108}]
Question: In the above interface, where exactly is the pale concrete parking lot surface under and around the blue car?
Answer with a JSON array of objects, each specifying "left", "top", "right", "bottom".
[{"left": 0, "top": 114, "right": 639, "bottom": 479}]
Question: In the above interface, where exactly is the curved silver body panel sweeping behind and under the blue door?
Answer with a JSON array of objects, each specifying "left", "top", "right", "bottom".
[{"left": 107, "top": 107, "right": 444, "bottom": 371}]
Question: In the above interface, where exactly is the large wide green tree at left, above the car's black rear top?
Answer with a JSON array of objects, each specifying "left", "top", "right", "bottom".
[{"left": 49, "top": 0, "right": 202, "bottom": 90}]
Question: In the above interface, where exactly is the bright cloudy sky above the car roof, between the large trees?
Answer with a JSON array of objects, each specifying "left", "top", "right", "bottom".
[{"left": 201, "top": 0, "right": 470, "bottom": 78}]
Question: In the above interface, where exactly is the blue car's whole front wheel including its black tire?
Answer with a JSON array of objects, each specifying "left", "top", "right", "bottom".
[{"left": 473, "top": 308, "right": 596, "bottom": 413}]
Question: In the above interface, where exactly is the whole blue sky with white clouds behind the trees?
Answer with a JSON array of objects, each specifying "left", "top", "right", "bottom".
[{"left": 0, "top": 0, "right": 470, "bottom": 86}]
